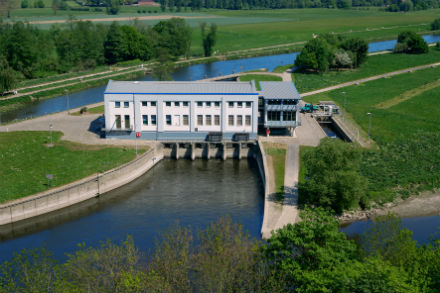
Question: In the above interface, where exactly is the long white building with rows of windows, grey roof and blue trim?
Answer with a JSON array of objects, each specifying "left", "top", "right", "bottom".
[{"left": 104, "top": 81, "right": 258, "bottom": 141}]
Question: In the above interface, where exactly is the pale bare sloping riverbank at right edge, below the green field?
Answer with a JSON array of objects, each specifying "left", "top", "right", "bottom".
[{"left": 338, "top": 190, "right": 440, "bottom": 225}]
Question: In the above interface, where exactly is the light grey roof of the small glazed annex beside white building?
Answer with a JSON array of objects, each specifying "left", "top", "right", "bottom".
[{"left": 260, "top": 81, "right": 301, "bottom": 100}]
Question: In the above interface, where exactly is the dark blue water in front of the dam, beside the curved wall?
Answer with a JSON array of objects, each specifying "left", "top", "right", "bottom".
[{"left": 0, "top": 160, "right": 264, "bottom": 262}]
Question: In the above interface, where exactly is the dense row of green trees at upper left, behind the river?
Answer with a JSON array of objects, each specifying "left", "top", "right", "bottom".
[{"left": 0, "top": 18, "right": 192, "bottom": 92}]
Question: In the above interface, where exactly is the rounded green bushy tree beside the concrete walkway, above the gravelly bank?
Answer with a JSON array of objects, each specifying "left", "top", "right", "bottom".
[{"left": 299, "top": 138, "right": 367, "bottom": 213}]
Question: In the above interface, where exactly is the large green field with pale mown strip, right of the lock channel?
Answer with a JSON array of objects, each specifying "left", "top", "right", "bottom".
[{"left": 305, "top": 67, "right": 440, "bottom": 202}]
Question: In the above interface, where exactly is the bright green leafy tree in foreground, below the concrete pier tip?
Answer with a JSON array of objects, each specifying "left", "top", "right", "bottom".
[{"left": 263, "top": 207, "right": 357, "bottom": 292}]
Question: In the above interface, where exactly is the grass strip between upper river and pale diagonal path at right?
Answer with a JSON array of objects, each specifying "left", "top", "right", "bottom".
[{"left": 292, "top": 47, "right": 440, "bottom": 93}]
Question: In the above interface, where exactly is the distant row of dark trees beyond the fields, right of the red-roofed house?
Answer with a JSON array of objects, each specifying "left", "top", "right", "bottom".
[{"left": 158, "top": 0, "right": 439, "bottom": 12}]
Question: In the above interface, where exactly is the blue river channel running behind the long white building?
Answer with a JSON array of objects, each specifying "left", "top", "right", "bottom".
[{"left": 0, "top": 35, "right": 440, "bottom": 122}]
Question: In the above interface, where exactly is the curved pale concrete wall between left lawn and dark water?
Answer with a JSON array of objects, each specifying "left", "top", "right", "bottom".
[{"left": 0, "top": 144, "right": 163, "bottom": 225}]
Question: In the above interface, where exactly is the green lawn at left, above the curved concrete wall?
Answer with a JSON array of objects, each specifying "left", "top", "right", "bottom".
[{"left": 0, "top": 131, "right": 144, "bottom": 202}]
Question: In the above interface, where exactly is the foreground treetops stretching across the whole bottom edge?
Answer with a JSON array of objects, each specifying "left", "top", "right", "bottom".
[{"left": 0, "top": 208, "right": 440, "bottom": 293}]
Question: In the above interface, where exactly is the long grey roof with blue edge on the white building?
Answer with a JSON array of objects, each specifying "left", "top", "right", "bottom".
[{"left": 104, "top": 80, "right": 258, "bottom": 95}]
